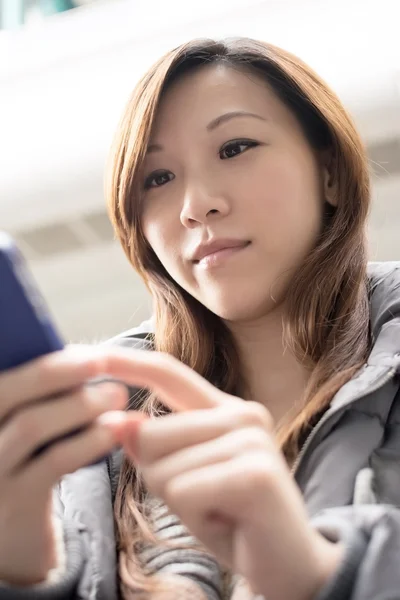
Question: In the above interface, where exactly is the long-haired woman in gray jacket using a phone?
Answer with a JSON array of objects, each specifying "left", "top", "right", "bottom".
[{"left": 0, "top": 39, "right": 400, "bottom": 600}]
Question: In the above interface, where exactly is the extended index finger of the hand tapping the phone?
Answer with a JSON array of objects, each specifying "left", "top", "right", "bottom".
[{"left": 104, "top": 348, "right": 231, "bottom": 411}]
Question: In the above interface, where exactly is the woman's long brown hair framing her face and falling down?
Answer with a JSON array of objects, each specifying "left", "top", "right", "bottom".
[{"left": 107, "top": 38, "right": 370, "bottom": 590}]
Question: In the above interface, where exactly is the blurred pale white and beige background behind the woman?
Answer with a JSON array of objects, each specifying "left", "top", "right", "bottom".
[{"left": 0, "top": 0, "right": 400, "bottom": 341}]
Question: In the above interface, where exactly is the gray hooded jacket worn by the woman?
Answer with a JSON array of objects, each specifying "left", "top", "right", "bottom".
[{"left": 0, "top": 263, "right": 400, "bottom": 600}]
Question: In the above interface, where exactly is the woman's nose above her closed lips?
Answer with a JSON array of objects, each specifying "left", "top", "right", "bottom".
[{"left": 180, "top": 186, "right": 230, "bottom": 229}]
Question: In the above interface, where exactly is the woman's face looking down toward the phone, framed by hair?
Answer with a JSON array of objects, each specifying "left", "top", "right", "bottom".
[{"left": 142, "top": 64, "right": 327, "bottom": 321}]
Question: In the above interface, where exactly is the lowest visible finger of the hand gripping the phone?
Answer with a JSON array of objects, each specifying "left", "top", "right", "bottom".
[{"left": 22, "top": 411, "right": 127, "bottom": 489}]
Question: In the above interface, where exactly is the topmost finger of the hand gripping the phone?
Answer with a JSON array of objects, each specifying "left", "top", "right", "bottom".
[{"left": 0, "top": 346, "right": 105, "bottom": 422}]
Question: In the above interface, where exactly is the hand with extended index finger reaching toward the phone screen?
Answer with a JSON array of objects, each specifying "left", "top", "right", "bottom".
[{"left": 103, "top": 349, "right": 342, "bottom": 600}]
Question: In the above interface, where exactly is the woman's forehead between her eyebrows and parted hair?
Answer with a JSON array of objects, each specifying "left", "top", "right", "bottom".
[{"left": 152, "top": 64, "right": 285, "bottom": 139}]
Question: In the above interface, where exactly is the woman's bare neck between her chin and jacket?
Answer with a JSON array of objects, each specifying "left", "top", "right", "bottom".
[{"left": 227, "top": 308, "right": 310, "bottom": 426}]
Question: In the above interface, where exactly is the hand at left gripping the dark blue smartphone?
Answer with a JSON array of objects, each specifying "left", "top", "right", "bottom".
[{"left": 0, "top": 348, "right": 127, "bottom": 585}]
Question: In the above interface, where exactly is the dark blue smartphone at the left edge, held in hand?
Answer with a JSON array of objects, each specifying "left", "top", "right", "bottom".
[{"left": 0, "top": 231, "right": 105, "bottom": 464}]
